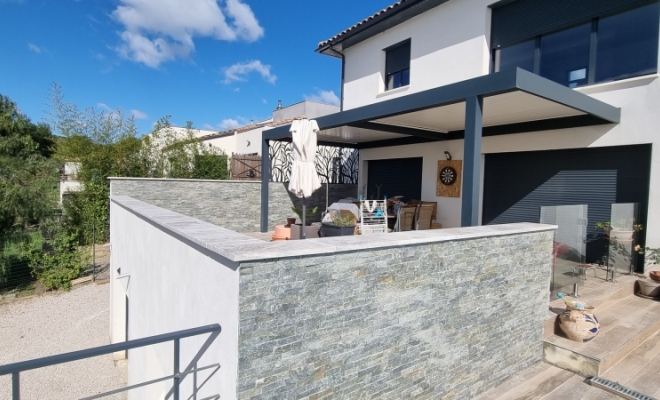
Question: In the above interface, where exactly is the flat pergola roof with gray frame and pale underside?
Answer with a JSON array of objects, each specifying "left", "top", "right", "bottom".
[{"left": 264, "top": 69, "right": 621, "bottom": 147}]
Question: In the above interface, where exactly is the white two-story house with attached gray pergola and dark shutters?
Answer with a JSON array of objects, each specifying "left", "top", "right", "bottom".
[{"left": 262, "top": 0, "right": 660, "bottom": 272}]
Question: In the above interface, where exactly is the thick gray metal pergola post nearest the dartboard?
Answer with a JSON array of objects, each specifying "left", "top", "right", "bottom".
[{"left": 461, "top": 96, "right": 483, "bottom": 226}]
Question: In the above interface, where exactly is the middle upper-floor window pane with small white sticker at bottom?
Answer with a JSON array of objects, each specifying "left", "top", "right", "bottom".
[{"left": 539, "top": 23, "right": 591, "bottom": 87}]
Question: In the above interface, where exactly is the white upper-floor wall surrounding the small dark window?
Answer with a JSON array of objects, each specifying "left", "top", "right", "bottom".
[{"left": 344, "top": 0, "right": 493, "bottom": 110}]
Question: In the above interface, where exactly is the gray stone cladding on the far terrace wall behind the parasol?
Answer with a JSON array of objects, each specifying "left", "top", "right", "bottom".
[{"left": 110, "top": 178, "right": 357, "bottom": 232}]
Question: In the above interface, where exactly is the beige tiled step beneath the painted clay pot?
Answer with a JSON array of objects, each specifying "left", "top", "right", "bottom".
[{"left": 543, "top": 287, "right": 660, "bottom": 377}]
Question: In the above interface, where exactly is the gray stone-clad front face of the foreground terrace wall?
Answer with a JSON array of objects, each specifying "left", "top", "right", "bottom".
[{"left": 238, "top": 231, "right": 553, "bottom": 400}]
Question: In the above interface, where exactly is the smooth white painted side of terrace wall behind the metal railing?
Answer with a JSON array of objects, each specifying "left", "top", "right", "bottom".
[{"left": 110, "top": 203, "right": 238, "bottom": 399}]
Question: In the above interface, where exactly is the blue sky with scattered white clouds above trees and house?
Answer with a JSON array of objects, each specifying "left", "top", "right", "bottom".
[{"left": 0, "top": 0, "right": 394, "bottom": 133}]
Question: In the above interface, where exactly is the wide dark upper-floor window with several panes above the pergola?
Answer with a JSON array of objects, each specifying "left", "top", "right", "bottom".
[{"left": 493, "top": 2, "right": 660, "bottom": 87}]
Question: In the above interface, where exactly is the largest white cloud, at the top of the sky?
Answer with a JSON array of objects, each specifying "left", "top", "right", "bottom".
[{"left": 112, "top": 0, "right": 264, "bottom": 68}]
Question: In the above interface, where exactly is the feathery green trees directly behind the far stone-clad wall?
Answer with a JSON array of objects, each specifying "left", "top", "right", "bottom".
[{"left": 50, "top": 85, "right": 229, "bottom": 244}]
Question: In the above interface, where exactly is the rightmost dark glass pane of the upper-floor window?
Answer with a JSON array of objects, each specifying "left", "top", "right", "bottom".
[{"left": 596, "top": 3, "right": 660, "bottom": 82}]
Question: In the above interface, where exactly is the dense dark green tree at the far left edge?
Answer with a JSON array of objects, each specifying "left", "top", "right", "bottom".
[{"left": 0, "top": 95, "right": 58, "bottom": 237}]
